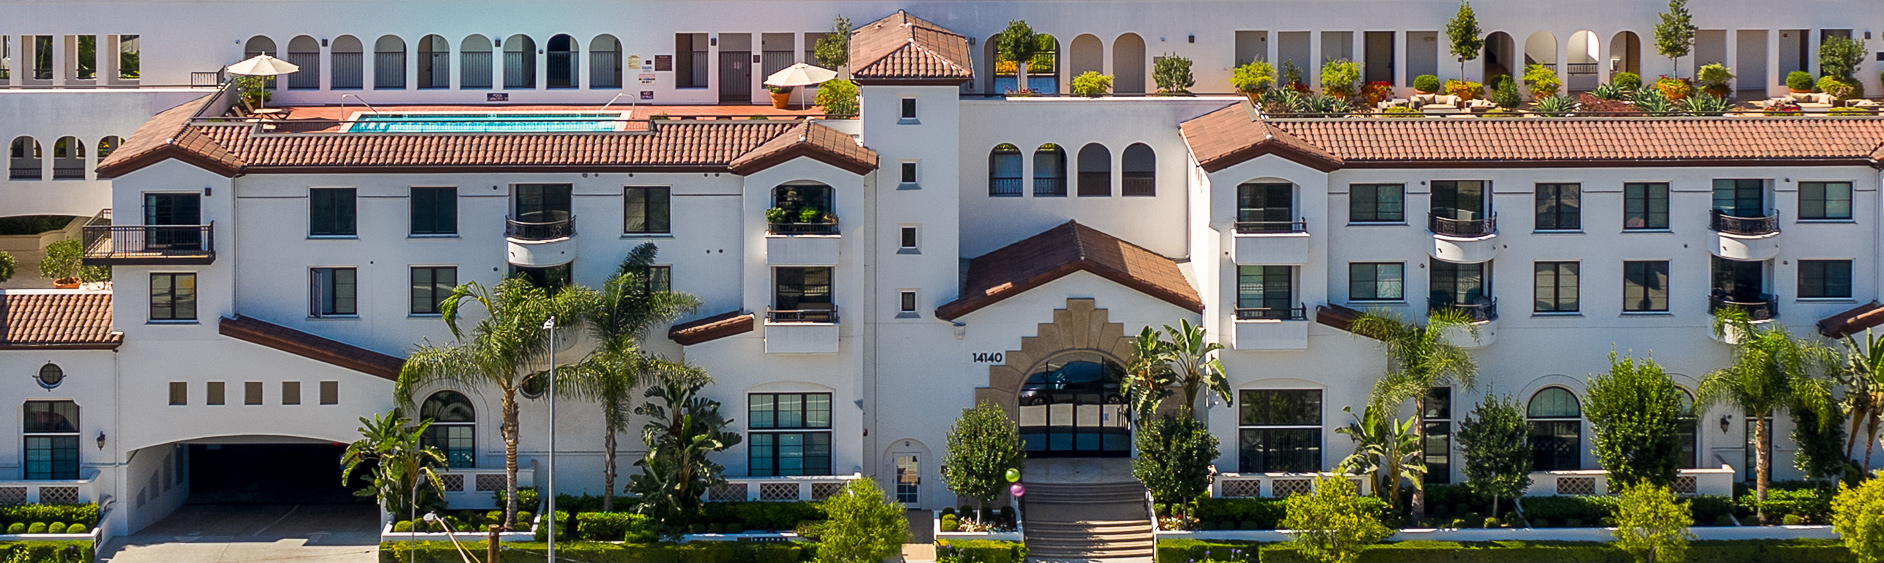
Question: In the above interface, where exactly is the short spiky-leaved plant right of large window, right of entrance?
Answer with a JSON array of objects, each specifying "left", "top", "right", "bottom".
[{"left": 1336, "top": 405, "right": 1426, "bottom": 507}]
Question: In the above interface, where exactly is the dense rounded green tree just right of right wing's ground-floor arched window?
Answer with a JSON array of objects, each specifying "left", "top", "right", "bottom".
[{"left": 1584, "top": 352, "right": 1682, "bottom": 486}]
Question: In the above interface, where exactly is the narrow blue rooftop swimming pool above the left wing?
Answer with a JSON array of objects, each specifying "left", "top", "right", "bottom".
[{"left": 347, "top": 113, "right": 624, "bottom": 134}]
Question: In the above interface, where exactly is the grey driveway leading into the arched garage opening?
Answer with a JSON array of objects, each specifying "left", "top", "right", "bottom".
[{"left": 98, "top": 505, "right": 379, "bottom": 563}]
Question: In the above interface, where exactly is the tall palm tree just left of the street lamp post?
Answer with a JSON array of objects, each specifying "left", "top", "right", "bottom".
[{"left": 396, "top": 277, "right": 597, "bottom": 527}]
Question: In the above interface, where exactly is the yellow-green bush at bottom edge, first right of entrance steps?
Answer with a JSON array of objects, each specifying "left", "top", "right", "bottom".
[{"left": 1283, "top": 476, "right": 1392, "bottom": 563}]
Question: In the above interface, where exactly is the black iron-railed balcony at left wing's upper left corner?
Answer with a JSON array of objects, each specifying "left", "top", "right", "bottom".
[{"left": 79, "top": 209, "right": 217, "bottom": 265}]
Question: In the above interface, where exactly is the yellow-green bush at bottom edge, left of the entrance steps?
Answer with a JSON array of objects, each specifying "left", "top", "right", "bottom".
[{"left": 816, "top": 478, "right": 910, "bottom": 563}]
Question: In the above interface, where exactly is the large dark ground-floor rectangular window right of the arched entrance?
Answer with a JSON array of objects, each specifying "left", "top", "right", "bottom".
[{"left": 1236, "top": 390, "right": 1321, "bottom": 473}]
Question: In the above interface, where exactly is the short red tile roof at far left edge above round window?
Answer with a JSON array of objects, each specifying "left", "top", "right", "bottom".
[{"left": 0, "top": 292, "right": 124, "bottom": 350}]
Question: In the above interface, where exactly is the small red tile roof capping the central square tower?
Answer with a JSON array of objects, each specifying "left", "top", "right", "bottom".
[{"left": 850, "top": 9, "right": 974, "bottom": 85}]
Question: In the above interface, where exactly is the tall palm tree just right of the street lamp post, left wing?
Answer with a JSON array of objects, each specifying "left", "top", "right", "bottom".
[{"left": 565, "top": 243, "right": 701, "bottom": 512}]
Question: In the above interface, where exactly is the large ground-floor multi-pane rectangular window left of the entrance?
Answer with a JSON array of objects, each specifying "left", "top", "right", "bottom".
[{"left": 746, "top": 394, "right": 831, "bottom": 476}]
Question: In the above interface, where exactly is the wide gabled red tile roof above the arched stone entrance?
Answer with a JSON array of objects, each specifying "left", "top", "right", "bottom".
[{"left": 936, "top": 220, "right": 1204, "bottom": 320}]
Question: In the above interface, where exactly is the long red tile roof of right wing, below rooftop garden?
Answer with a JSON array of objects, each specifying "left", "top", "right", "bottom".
[{"left": 1183, "top": 104, "right": 1884, "bottom": 171}]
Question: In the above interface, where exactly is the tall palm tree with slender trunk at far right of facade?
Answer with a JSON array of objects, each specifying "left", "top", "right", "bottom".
[{"left": 1696, "top": 307, "right": 1835, "bottom": 522}]
